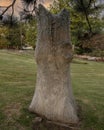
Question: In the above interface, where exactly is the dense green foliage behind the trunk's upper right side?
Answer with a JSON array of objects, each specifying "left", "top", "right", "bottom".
[{"left": 51, "top": 0, "right": 104, "bottom": 53}]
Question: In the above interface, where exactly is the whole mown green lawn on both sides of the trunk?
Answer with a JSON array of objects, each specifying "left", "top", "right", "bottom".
[{"left": 0, "top": 50, "right": 104, "bottom": 130}]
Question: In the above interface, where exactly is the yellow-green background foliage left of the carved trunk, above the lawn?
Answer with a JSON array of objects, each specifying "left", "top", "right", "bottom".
[{"left": 0, "top": 19, "right": 37, "bottom": 49}]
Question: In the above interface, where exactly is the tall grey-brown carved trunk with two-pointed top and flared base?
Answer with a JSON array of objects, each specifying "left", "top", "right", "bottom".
[{"left": 29, "top": 5, "right": 78, "bottom": 124}]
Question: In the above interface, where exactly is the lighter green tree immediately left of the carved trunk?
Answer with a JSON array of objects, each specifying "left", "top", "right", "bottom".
[{"left": 20, "top": 12, "right": 37, "bottom": 48}]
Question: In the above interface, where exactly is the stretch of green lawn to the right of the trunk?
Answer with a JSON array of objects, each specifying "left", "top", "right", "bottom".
[{"left": 72, "top": 59, "right": 104, "bottom": 130}]
